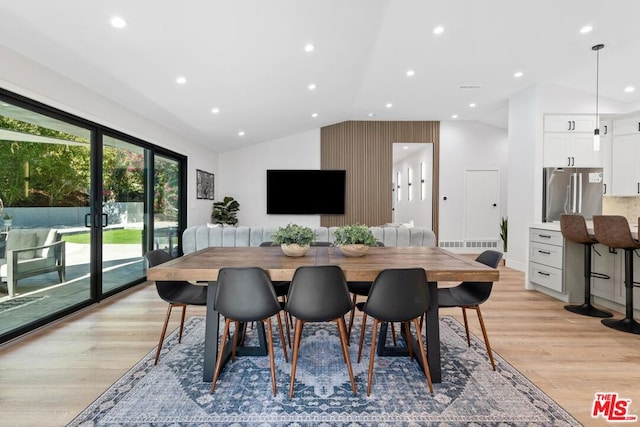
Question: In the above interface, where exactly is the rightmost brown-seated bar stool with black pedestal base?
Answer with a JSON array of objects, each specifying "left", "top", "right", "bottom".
[{"left": 593, "top": 215, "right": 640, "bottom": 334}]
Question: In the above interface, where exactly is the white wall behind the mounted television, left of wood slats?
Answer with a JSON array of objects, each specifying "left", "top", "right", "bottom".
[{"left": 216, "top": 129, "right": 320, "bottom": 227}]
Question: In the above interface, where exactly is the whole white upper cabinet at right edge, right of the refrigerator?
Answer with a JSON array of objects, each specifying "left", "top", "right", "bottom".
[{"left": 608, "top": 116, "right": 640, "bottom": 196}]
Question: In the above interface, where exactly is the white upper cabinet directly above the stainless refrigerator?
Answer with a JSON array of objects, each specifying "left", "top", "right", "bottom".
[{"left": 543, "top": 114, "right": 609, "bottom": 167}]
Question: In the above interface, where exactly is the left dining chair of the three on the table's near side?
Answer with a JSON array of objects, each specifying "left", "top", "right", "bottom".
[{"left": 211, "top": 267, "right": 289, "bottom": 396}]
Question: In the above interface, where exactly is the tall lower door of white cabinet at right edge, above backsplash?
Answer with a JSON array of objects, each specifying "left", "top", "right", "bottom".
[{"left": 609, "top": 135, "right": 640, "bottom": 196}]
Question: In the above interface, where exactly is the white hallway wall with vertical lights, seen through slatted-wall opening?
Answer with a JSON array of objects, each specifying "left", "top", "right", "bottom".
[{"left": 392, "top": 144, "right": 433, "bottom": 228}]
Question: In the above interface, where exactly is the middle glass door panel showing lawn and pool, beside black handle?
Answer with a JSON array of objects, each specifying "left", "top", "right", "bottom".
[{"left": 100, "top": 135, "right": 149, "bottom": 294}]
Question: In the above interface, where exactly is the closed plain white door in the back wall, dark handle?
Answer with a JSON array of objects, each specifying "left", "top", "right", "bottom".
[{"left": 464, "top": 170, "right": 500, "bottom": 244}]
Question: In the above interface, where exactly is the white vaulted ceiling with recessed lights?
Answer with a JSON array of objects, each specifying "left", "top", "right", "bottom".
[{"left": 0, "top": 0, "right": 640, "bottom": 152}]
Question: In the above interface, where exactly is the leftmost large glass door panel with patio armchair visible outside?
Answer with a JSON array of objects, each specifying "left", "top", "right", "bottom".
[{"left": 0, "top": 101, "right": 92, "bottom": 338}]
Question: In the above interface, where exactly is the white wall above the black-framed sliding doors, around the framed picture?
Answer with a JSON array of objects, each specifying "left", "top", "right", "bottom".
[{"left": 0, "top": 46, "right": 218, "bottom": 225}]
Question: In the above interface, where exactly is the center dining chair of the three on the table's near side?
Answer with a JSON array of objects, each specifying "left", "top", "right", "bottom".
[{"left": 286, "top": 265, "right": 357, "bottom": 398}]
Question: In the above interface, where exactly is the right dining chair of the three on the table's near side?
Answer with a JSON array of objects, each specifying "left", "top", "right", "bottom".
[{"left": 358, "top": 268, "right": 433, "bottom": 396}]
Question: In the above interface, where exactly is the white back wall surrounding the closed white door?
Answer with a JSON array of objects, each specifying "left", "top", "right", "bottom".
[{"left": 438, "top": 121, "right": 511, "bottom": 246}]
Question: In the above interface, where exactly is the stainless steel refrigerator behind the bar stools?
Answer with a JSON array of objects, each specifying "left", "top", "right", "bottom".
[{"left": 542, "top": 168, "right": 603, "bottom": 222}]
